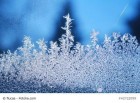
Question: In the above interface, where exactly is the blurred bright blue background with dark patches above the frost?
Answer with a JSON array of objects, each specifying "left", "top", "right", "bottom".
[{"left": 0, "top": 0, "right": 140, "bottom": 53}]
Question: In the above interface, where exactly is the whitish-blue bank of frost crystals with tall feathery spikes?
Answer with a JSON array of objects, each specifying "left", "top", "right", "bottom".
[{"left": 0, "top": 14, "right": 140, "bottom": 92}]
